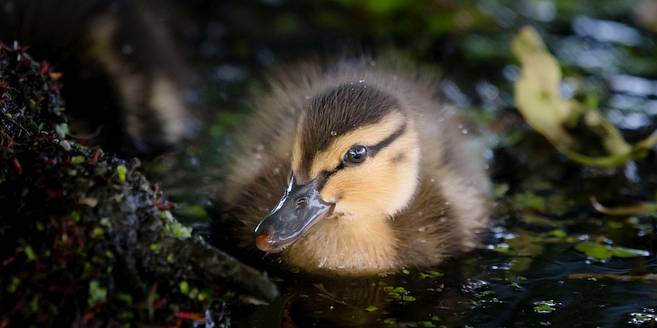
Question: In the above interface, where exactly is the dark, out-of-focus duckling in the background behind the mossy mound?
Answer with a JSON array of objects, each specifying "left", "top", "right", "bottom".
[{"left": 0, "top": 0, "right": 197, "bottom": 154}]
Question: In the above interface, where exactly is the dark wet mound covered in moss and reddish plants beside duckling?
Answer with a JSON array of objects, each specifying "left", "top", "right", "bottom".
[{"left": 0, "top": 44, "right": 278, "bottom": 327}]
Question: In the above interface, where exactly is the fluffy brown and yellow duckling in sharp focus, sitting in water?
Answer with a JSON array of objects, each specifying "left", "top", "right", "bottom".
[{"left": 220, "top": 59, "right": 489, "bottom": 276}]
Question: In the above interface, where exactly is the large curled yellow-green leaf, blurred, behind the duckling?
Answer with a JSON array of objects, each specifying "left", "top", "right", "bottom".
[{"left": 512, "top": 26, "right": 657, "bottom": 167}]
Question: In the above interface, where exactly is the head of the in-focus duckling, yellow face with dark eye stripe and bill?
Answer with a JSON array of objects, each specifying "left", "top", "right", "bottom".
[{"left": 255, "top": 82, "right": 420, "bottom": 252}]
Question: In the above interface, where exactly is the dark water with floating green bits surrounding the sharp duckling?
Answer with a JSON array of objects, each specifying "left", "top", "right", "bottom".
[{"left": 148, "top": 0, "right": 657, "bottom": 327}]
